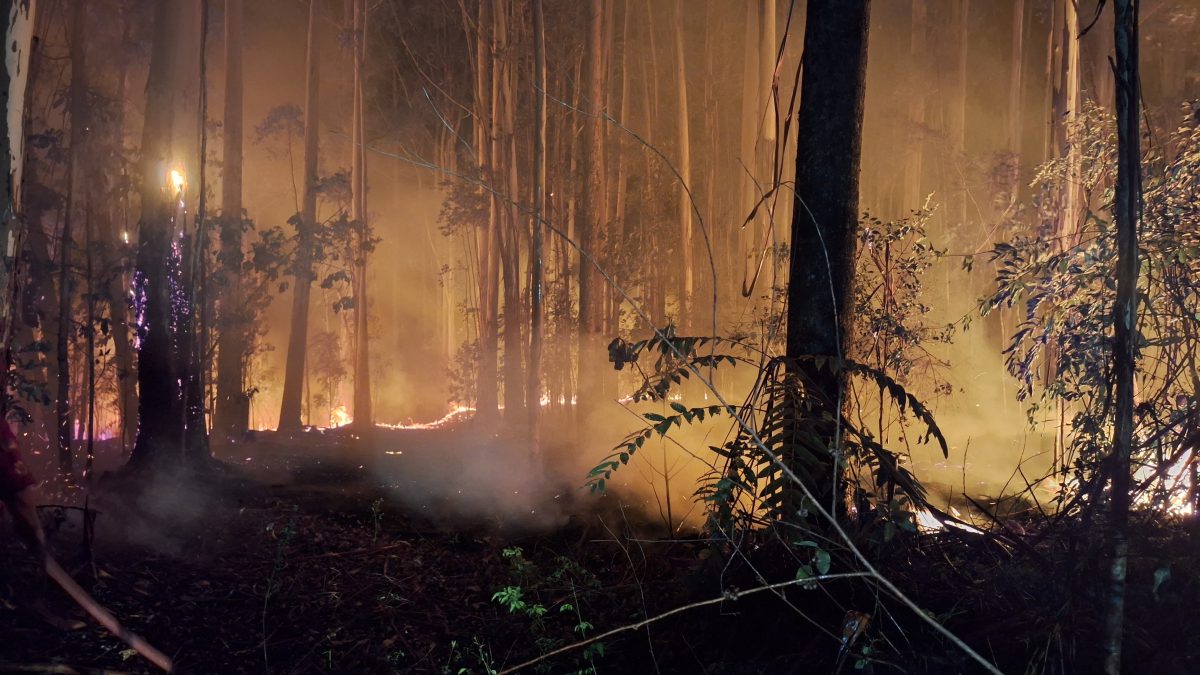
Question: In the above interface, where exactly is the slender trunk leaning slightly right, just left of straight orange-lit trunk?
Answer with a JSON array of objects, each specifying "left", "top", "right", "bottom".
[{"left": 278, "top": 0, "right": 320, "bottom": 431}]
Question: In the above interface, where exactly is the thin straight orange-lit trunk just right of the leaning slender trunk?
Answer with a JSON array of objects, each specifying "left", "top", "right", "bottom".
[{"left": 350, "top": 0, "right": 373, "bottom": 430}]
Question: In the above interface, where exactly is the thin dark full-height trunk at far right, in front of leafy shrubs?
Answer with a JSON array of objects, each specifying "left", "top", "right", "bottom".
[{"left": 1104, "top": 0, "right": 1141, "bottom": 675}]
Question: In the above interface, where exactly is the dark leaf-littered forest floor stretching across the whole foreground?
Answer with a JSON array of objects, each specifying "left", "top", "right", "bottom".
[{"left": 0, "top": 429, "right": 1200, "bottom": 675}]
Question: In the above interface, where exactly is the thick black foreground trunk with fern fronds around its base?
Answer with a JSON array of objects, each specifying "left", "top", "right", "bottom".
[{"left": 787, "top": 0, "right": 870, "bottom": 514}]
